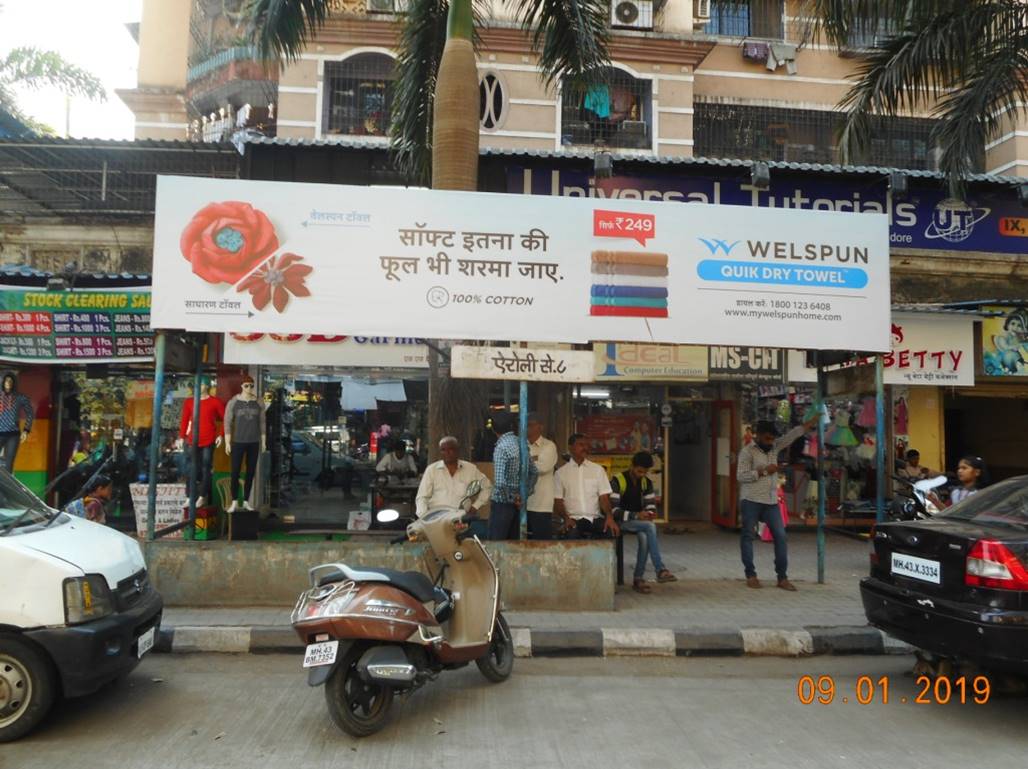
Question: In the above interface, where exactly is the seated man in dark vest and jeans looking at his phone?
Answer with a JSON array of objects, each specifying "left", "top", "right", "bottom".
[{"left": 611, "top": 451, "right": 678, "bottom": 593}]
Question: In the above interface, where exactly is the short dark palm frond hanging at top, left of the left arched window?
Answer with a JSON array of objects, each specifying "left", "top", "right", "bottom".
[{"left": 246, "top": 0, "right": 331, "bottom": 62}]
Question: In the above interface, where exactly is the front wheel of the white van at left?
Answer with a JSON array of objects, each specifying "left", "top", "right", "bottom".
[{"left": 0, "top": 635, "right": 58, "bottom": 742}]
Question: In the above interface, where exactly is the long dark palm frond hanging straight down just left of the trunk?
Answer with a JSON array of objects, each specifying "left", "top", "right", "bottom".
[{"left": 390, "top": 0, "right": 449, "bottom": 184}]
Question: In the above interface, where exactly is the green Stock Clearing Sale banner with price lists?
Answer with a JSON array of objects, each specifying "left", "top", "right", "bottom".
[{"left": 0, "top": 288, "right": 153, "bottom": 363}]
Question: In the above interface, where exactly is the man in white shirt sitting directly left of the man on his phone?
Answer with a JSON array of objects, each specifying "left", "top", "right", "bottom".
[{"left": 553, "top": 433, "right": 620, "bottom": 537}]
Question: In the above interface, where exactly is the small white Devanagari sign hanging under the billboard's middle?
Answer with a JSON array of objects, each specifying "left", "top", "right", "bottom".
[{"left": 450, "top": 344, "right": 592, "bottom": 382}]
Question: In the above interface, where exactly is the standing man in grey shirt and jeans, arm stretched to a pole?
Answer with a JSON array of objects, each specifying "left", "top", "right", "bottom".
[{"left": 737, "top": 414, "right": 818, "bottom": 590}]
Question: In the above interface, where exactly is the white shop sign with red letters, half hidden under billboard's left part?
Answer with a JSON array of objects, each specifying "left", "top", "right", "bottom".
[{"left": 224, "top": 333, "right": 429, "bottom": 368}]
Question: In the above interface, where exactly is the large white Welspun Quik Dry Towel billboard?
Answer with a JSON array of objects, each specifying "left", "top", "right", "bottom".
[{"left": 152, "top": 177, "right": 889, "bottom": 351}]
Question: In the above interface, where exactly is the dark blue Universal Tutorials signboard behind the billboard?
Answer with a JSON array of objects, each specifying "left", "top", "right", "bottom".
[{"left": 507, "top": 168, "right": 1028, "bottom": 254}]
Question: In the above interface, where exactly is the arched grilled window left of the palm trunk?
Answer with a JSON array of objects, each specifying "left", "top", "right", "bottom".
[{"left": 322, "top": 53, "right": 396, "bottom": 137}]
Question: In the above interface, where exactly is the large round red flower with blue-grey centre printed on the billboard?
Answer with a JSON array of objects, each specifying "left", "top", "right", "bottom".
[{"left": 179, "top": 200, "right": 279, "bottom": 283}]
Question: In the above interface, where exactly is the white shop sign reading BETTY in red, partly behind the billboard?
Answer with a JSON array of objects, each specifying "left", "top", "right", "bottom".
[{"left": 788, "top": 313, "right": 975, "bottom": 387}]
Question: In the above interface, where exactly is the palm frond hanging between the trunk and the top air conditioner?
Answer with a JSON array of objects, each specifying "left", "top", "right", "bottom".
[{"left": 512, "top": 0, "right": 611, "bottom": 85}]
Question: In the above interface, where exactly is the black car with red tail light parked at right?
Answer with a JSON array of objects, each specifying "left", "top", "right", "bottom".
[{"left": 860, "top": 476, "right": 1028, "bottom": 675}]
